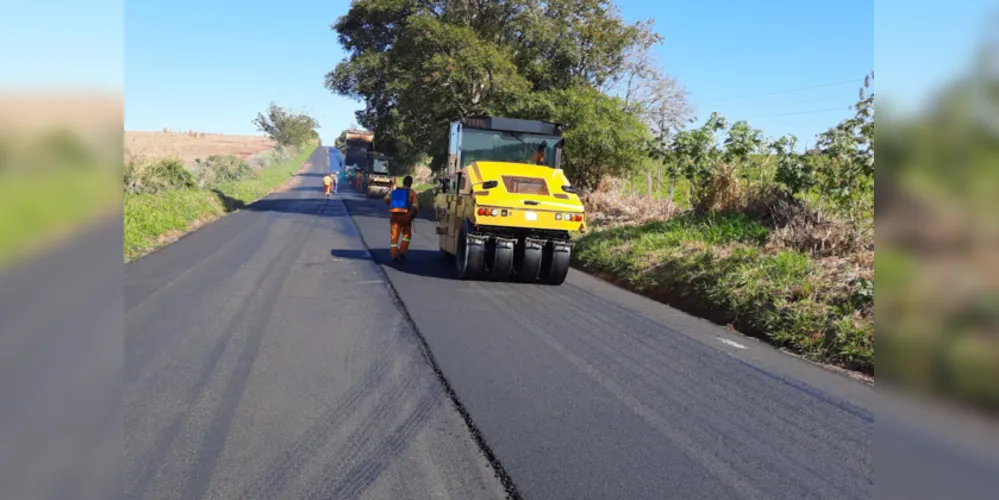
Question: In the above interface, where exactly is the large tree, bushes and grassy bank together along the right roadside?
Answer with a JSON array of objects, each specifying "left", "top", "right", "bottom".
[{"left": 326, "top": 0, "right": 874, "bottom": 373}]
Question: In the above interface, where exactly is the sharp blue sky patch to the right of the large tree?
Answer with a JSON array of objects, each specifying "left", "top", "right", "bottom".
[{"left": 619, "top": 0, "right": 874, "bottom": 145}]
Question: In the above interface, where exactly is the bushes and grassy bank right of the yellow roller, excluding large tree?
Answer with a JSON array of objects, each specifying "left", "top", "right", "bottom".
[{"left": 575, "top": 77, "right": 874, "bottom": 373}]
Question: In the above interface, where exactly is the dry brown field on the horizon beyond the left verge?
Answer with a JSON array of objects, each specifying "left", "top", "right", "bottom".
[{"left": 124, "top": 130, "right": 277, "bottom": 164}]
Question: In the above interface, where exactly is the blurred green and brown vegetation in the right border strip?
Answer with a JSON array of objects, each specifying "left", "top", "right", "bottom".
[{"left": 877, "top": 63, "right": 999, "bottom": 414}]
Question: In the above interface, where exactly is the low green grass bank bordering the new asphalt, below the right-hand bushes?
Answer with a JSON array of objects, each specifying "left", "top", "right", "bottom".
[{"left": 573, "top": 214, "right": 874, "bottom": 372}]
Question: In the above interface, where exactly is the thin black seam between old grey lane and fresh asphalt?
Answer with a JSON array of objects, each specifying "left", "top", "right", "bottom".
[{"left": 340, "top": 199, "right": 523, "bottom": 500}]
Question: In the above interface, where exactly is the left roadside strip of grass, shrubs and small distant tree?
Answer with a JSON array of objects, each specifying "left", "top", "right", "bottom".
[{"left": 122, "top": 104, "right": 318, "bottom": 262}]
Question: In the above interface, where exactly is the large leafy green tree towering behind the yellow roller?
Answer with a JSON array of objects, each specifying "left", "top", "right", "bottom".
[{"left": 326, "top": 0, "right": 651, "bottom": 183}]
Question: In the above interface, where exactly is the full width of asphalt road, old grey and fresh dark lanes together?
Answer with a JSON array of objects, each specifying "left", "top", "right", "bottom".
[{"left": 124, "top": 149, "right": 999, "bottom": 499}]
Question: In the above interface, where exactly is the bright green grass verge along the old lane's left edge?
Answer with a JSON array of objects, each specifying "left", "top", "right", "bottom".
[{"left": 124, "top": 147, "right": 314, "bottom": 262}]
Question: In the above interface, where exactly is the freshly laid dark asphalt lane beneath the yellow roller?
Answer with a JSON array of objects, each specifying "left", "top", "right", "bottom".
[{"left": 345, "top": 178, "right": 999, "bottom": 499}]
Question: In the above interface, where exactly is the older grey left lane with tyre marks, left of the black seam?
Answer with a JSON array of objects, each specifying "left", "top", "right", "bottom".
[{"left": 124, "top": 148, "right": 505, "bottom": 499}]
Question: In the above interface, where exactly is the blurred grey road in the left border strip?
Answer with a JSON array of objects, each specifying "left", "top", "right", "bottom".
[{"left": 0, "top": 214, "right": 122, "bottom": 500}]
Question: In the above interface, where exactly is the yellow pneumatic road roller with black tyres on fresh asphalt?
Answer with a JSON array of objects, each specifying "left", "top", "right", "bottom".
[{"left": 434, "top": 116, "right": 586, "bottom": 285}]
